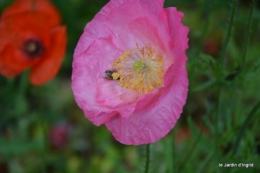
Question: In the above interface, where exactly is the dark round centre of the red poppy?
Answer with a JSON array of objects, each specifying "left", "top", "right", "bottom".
[{"left": 23, "top": 39, "right": 44, "bottom": 58}]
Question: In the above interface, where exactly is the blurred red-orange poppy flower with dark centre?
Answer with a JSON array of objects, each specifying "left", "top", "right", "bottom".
[{"left": 0, "top": 0, "right": 67, "bottom": 85}]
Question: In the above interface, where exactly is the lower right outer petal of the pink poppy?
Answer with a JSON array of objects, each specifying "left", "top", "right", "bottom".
[{"left": 106, "top": 58, "right": 188, "bottom": 145}]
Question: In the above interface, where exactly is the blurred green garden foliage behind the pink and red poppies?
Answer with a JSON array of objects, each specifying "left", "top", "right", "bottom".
[{"left": 0, "top": 0, "right": 260, "bottom": 173}]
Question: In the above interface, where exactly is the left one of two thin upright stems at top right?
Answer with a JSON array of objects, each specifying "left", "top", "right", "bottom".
[{"left": 219, "top": 0, "right": 238, "bottom": 69}]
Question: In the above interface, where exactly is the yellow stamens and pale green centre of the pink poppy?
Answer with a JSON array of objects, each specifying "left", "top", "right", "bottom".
[{"left": 112, "top": 46, "right": 165, "bottom": 93}]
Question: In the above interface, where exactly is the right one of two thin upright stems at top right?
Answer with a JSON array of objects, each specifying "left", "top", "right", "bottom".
[{"left": 242, "top": 0, "right": 257, "bottom": 70}]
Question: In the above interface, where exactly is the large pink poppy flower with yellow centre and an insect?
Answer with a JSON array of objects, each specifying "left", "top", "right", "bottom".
[{"left": 72, "top": 0, "right": 188, "bottom": 145}]
